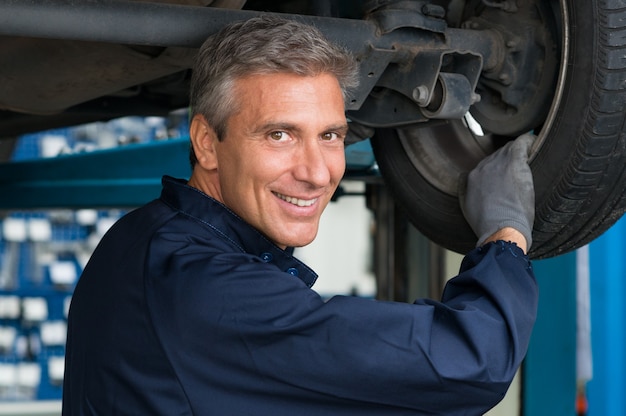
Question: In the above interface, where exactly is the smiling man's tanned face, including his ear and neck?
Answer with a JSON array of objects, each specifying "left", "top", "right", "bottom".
[{"left": 189, "top": 73, "right": 348, "bottom": 248}]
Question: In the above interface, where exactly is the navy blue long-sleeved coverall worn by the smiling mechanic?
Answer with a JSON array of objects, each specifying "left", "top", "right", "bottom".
[{"left": 63, "top": 177, "right": 537, "bottom": 416}]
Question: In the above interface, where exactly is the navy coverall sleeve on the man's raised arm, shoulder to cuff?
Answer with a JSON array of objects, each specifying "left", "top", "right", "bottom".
[{"left": 147, "top": 242, "right": 537, "bottom": 415}]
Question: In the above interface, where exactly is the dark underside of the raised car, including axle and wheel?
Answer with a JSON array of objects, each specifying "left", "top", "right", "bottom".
[{"left": 0, "top": 0, "right": 626, "bottom": 257}]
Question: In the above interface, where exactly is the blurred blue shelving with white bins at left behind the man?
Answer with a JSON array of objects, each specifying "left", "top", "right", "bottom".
[{"left": 0, "top": 118, "right": 187, "bottom": 401}]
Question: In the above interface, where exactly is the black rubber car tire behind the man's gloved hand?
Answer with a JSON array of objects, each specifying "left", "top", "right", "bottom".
[{"left": 371, "top": 0, "right": 626, "bottom": 258}]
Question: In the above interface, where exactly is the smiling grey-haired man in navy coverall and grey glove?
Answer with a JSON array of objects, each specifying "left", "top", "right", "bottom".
[{"left": 63, "top": 14, "right": 537, "bottom": 416}]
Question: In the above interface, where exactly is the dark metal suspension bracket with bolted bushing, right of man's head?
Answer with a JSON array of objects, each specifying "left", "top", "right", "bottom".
[{"left": 348, "top": 1, "right": 490, "bottom": 127}]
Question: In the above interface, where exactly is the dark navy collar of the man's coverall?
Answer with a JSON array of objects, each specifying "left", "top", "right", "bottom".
[{"left": 160, "top": 176, "right": 317, "bottom": 287}]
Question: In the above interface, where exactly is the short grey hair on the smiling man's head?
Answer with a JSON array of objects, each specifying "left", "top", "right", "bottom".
[{"left": 189, "top": 15, "right": 359, "bottom": 167}]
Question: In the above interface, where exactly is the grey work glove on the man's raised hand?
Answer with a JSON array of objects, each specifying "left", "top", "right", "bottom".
[{"left": 459, "top": 134, "right": 535, "bottom": 250}]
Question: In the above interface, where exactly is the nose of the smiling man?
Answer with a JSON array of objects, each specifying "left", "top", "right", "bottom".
[{"left": 294, "top": 140, "right": 332, "bottom": 187}]
